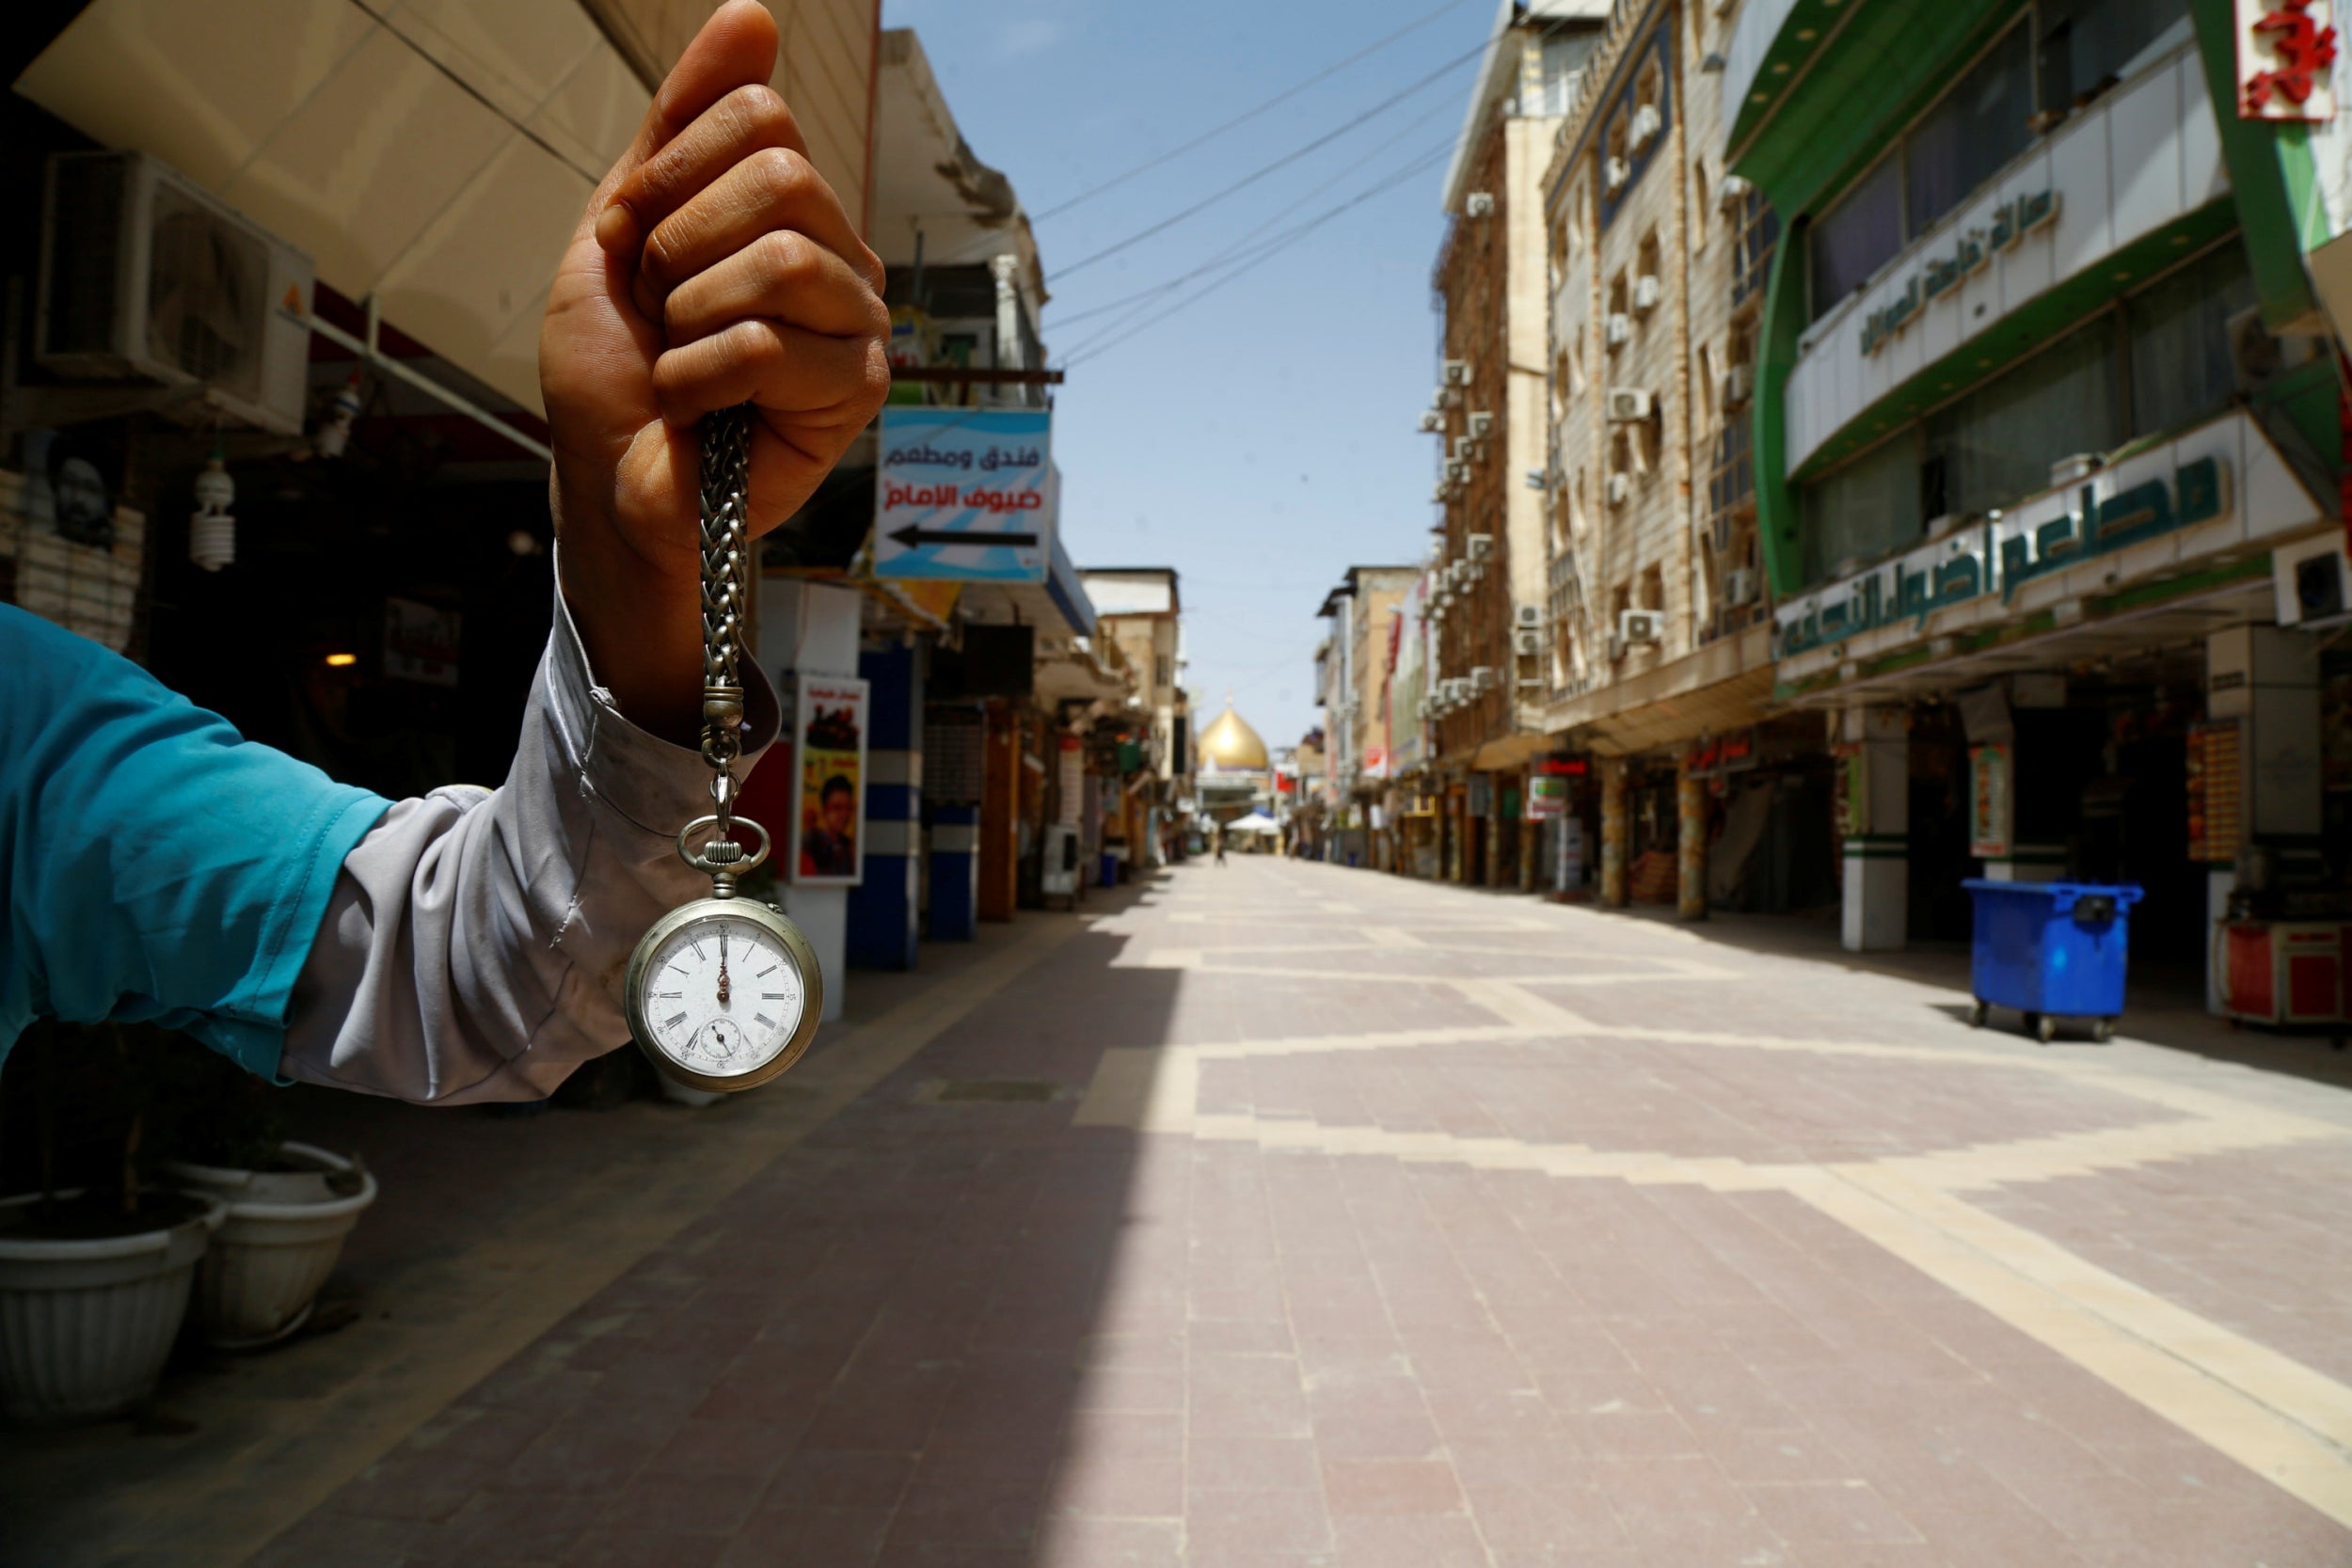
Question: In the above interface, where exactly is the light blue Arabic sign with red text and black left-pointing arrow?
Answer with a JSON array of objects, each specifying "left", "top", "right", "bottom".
[{"left": 875, "top": 406, "right": 1061, "bottom": 583}]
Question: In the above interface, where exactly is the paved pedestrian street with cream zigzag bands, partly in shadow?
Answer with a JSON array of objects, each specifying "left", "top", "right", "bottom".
[{"left": 0, "top": 856, "right": 2352, "bottom": 1568}]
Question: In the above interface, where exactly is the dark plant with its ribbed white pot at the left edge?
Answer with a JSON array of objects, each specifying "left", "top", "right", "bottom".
[{"left": 0, "top": 1025, "right": 226, "bottom": 1422}]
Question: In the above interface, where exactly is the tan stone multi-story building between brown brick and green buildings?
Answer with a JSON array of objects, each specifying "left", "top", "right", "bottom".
[{"left": 1524, "top": 0, "right": 1778, "bottom": 917}]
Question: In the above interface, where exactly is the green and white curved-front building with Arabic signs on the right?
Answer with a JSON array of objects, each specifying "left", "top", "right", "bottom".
[{"left": 1722, "top": 0, "right": 2352, "bottom": 991}]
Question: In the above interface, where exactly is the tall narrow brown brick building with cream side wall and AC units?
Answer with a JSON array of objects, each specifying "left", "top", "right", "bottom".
[{"left": 1421, "top": 0, "right": 1607, "bottom": 886}]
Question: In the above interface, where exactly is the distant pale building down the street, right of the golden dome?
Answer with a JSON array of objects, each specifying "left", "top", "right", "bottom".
[{"left": 1317, "top": 566, "right": 1421, "bottom": 870}]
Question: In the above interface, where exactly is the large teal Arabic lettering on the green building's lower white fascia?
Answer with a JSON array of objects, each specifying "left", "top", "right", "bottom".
[{"left": 1773, "top": 456, "right": 2230, "bottom": 658}]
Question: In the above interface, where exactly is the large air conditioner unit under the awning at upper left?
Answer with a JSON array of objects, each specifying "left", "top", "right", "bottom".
[{"left": 33, "top": 152, "right": 310, "bottom": 435}]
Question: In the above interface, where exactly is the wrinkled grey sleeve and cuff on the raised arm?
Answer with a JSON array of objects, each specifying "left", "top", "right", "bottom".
[{"left": 278, "top": 582, "right": 779, "bottom": 1105}]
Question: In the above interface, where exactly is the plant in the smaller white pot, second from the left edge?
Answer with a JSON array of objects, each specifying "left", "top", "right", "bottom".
[{"left": 165, "top": 1051, "right": 376, "bottom": 1350}]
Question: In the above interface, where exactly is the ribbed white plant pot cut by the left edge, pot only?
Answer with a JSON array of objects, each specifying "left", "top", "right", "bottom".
[{"left": 0, "top": 1192, "right": 226, "bottom": 1422}]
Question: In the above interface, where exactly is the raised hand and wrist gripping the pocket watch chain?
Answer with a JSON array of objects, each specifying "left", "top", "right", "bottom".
[{"left": 539, "top": 0, "right": 889, "bottom": 743}]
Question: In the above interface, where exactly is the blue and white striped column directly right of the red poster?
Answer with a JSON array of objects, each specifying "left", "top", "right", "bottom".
[{"left": 850, "top": 641, "right": 922, "bottom": 969}]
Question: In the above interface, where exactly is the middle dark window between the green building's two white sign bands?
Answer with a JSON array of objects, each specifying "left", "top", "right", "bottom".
[{"left": 1919, "top": 315, "right": 2124, "bottom": 517}]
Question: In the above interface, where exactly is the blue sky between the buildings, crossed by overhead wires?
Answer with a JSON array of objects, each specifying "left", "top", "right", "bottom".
[{"left": 882, "top": 0, "right": 1496, "bottom": 748}]
